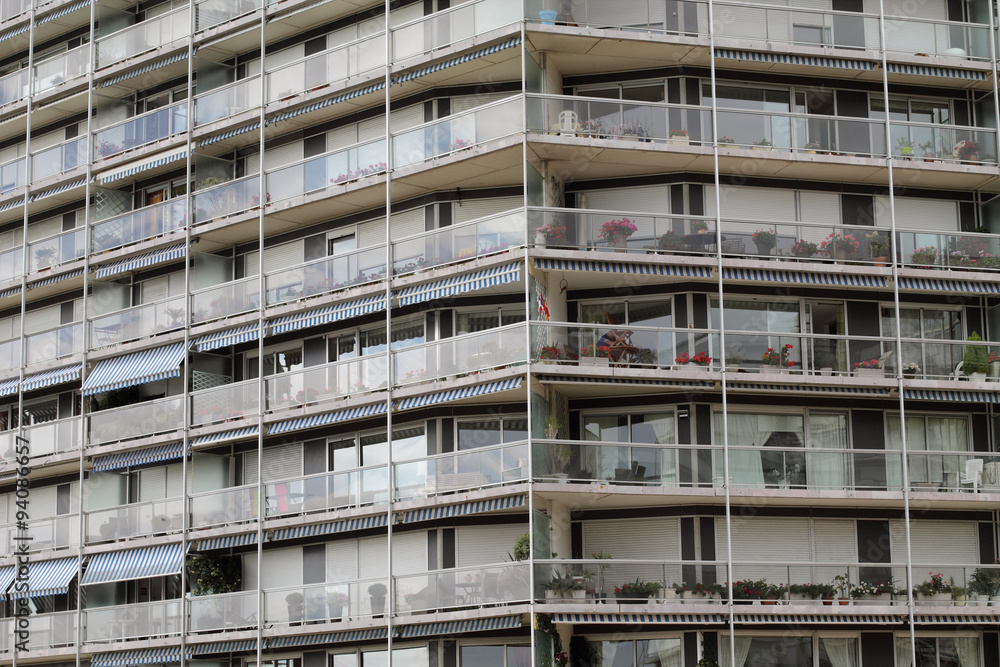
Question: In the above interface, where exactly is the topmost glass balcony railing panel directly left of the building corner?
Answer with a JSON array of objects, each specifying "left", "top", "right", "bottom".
[{"left": 392, "top": 0, "right": 521, "bottom": 60}]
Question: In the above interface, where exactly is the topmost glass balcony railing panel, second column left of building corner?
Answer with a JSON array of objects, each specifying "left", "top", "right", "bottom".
[{"left": 267, "top": 32, "right": 385, "bottom": 102}]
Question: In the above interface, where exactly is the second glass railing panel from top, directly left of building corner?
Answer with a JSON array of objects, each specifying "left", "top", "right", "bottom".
[{"left": 392, "top": 95, "right": 524, "bottom": 168}]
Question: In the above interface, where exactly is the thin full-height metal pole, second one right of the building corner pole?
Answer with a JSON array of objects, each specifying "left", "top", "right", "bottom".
[{"left": 876, "top": 0, "right": 916, "bottom": 665}]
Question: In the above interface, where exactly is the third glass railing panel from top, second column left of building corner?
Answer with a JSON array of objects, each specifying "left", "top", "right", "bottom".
[{"left": 264, "top": 244, "right": 385, "bottom": 306}]
